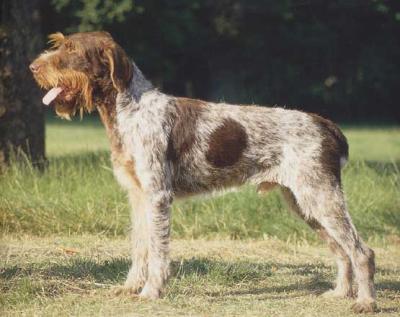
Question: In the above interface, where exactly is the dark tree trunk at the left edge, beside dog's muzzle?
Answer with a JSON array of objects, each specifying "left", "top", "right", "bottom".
[{"left": 0, "top": 0, "right": 45, "bottom": 170}]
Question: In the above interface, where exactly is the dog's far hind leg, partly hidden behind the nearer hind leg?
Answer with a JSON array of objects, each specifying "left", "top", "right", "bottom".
[{"left": 281, "top": 187, "right": 353, "bottom": 297}]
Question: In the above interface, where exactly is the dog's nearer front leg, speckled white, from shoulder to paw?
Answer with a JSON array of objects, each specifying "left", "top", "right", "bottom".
[{"left": 127, "top": 119, "right": 173, "bottom": 299}]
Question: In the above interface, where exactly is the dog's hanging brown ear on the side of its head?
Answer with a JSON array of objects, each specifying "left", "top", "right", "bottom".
[{"left": 104, "top": 43, "right": 133, "bottom": 92}]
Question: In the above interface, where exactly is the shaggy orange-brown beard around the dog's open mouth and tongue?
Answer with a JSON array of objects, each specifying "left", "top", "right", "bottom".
[{"left": 35, "top": 69, "right": 94, "bottom": 120}]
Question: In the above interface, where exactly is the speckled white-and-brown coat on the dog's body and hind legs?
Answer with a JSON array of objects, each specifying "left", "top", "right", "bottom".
[{"left": 112, "top": 66, "right": 374, "bottom": 312}]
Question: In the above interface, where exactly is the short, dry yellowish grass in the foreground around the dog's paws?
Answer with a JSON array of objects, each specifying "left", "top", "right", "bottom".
[{"left": 0, "top": 235, "right": 400, "bottom": 317}]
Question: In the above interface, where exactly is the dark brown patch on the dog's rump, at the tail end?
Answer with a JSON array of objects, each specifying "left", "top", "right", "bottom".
[{"left": 310, "top": 114, "right": 349, "bottom": 180}]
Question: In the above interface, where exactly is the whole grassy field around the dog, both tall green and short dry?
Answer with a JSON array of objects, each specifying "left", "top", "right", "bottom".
[{"left": 0, "top": 118, "right": 400, "bottom": 316}]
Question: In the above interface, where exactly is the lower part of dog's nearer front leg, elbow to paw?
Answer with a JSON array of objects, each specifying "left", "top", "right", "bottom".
[{"left": 140, "top": 190, "right": 172, "bottom": 299}]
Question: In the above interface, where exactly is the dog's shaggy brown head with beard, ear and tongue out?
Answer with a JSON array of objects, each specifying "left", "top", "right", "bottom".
[{"left": 29, "top": 32, "right": 132, "bottom": 119}]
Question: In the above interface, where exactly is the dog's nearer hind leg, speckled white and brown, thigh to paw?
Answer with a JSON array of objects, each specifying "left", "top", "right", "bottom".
[{"left": 286, "top": 181, "right": 376, "bottom": 313}]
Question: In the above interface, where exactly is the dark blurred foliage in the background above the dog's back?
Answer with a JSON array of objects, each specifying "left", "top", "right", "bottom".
[{"left": 43, "top": 0, "right": 400, "bottom": 121}]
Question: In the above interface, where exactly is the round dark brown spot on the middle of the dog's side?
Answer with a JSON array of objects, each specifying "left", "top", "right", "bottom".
[{"left": 206, "top": 119, "right": 247, "bottom": 168}]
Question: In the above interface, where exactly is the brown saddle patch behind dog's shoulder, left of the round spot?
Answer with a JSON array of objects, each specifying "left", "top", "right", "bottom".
[{"left": 167, "top": 98, "right": 206, "bottom": 162}]
